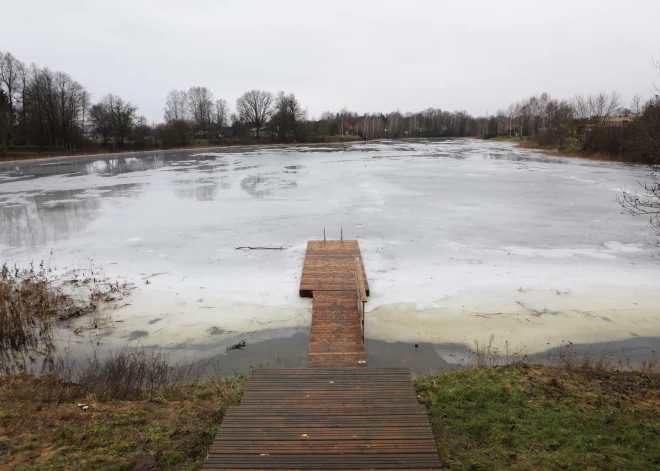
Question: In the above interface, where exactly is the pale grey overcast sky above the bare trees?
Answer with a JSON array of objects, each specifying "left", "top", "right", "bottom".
[{"left": 0, "top": 0, "right": 660, "bottom": 121}]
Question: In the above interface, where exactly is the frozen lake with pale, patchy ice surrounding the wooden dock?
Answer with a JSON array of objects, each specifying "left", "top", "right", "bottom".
[{"left": 0, "top": 139, "right": 660, "bottom": 367}]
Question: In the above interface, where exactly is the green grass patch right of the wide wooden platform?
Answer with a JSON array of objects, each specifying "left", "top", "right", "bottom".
[{"left": 415, "top": 364, "right": 660, "bottom": 471}]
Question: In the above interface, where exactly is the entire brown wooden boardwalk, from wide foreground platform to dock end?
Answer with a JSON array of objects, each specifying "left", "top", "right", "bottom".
[{"left": 204, "top": 241, "right": 441, "bottom": 470}]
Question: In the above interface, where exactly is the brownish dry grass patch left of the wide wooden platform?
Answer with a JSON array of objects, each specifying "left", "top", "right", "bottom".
[{"left": 0, "top": 374, "right": 245, "bottom": 470}]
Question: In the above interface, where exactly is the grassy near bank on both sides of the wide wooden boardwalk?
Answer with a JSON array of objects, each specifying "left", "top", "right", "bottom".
[{"left": 0, "top": 363, "right": 660, "bottom": 470}]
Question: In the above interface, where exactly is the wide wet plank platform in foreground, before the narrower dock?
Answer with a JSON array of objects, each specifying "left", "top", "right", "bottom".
[{"left": 204, "top": 368, "right": 440, "bottom": 470}]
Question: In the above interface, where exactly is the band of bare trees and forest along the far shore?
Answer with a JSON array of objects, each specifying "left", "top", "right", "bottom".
[{"left": 0, "top": 52, "right": 660, "bottom": 163}]
